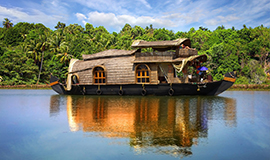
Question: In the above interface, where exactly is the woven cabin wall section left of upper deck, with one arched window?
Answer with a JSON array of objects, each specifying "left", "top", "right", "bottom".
[{"left": 74, "top": 56, "right": 135, "bottom": 85}]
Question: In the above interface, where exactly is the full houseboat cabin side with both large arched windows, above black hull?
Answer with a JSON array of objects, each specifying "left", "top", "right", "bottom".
[{"left": 71, "top": 56, "right": 194, "bottom": 85}]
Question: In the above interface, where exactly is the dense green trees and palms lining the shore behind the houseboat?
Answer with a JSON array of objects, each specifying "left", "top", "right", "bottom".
[{"left": 0, "top": 19, "right": 270, "bottom": 85}]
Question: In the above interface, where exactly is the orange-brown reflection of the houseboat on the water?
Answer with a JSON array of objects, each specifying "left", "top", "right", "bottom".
[{"left": 51, "top": 95, "right": 236, "bottom": 156}]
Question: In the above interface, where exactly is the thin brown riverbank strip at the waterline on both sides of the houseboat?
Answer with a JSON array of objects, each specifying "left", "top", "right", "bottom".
[{"left": 0, "top": 84, "right": 270, "bottom": 91}]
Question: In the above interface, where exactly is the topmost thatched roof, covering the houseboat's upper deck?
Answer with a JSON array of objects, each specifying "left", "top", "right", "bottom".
[{"left": 131, "top": 38, "right": 191, "bottom": 48}]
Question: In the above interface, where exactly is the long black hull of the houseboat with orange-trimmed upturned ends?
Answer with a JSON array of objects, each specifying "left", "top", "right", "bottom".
[{"left": 51, "top": 72, "right": 235, "bottom": 96}]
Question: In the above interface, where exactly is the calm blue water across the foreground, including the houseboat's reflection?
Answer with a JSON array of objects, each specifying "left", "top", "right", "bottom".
[{"left": 0, "top": 90, "right": 270, "bottom": 160}]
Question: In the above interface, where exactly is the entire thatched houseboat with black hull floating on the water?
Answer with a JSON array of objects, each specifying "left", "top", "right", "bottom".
[{"left": 50, "top": 38, "right": 236, "bottom": 96}]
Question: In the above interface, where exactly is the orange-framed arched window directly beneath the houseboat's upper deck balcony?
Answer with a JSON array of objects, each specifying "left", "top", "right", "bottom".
[{"left": 136, "top": 64, "right": 150, "bottom": 83}]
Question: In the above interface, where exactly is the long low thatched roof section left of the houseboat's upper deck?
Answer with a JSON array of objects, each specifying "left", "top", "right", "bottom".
[{"left": 82, "top": 49, "right": 136, "bottom": 61}]
